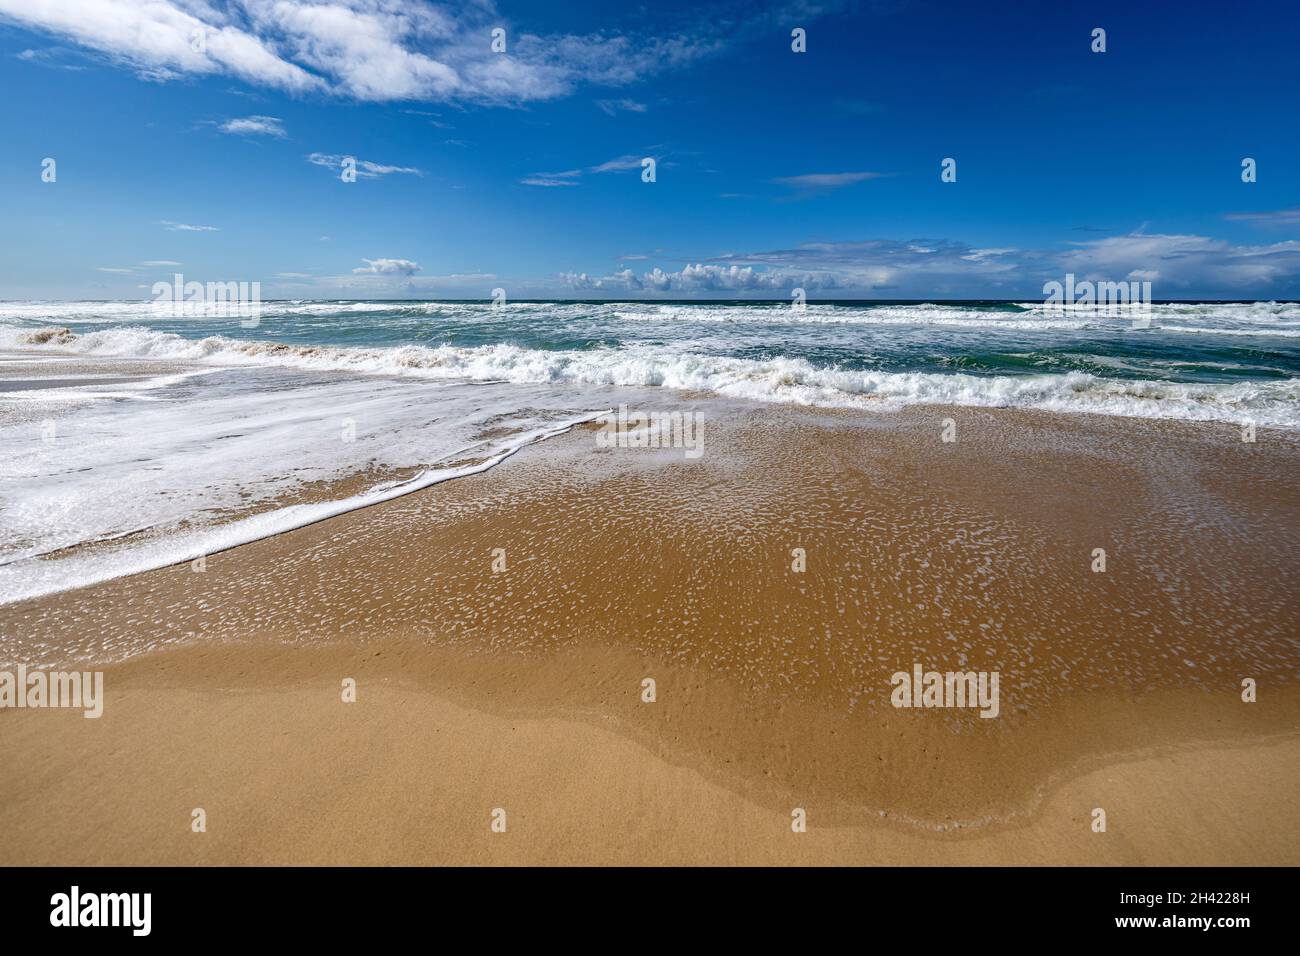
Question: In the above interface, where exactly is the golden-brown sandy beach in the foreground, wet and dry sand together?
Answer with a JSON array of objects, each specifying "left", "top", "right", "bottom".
[{"left": 0, "top": 403, "right": 1300, "bottom": 865}]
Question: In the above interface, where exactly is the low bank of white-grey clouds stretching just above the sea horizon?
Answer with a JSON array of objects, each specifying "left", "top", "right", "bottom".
[{"left": 65, "top": 224, "right": 1300, "bottom": 302}]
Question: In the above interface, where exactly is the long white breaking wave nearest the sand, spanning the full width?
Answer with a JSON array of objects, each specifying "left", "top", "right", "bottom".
[{"left": 0, "top": 326, "right": 1300, "bottom": 428}]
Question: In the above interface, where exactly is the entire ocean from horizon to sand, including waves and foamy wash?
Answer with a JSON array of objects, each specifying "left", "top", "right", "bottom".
[{"left": 0, "top": 300, "right": 1300, "bottom": 604}]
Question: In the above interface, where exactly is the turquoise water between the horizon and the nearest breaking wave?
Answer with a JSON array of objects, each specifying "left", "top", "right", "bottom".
[{"left": 10, "top": 300, "right": 1300, "bottom": 382}]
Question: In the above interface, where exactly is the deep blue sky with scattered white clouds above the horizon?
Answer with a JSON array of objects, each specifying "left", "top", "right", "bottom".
[{"left": 0, "top": 0, "right": 1300, "bottom": 300}]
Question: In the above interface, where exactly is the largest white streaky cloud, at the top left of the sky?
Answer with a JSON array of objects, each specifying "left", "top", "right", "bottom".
[{"left": 0, "top": 0, "right": 723, "bottom": 105}]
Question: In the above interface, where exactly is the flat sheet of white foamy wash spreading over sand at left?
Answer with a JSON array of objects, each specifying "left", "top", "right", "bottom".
[{"left": 0, "top": 356, "right": 603, "bottom": 602}]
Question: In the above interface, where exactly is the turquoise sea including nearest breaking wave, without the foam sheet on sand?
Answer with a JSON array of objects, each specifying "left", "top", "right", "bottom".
[{"left": 0, "top": 300, "right": 1300, "bottom": 425}]
